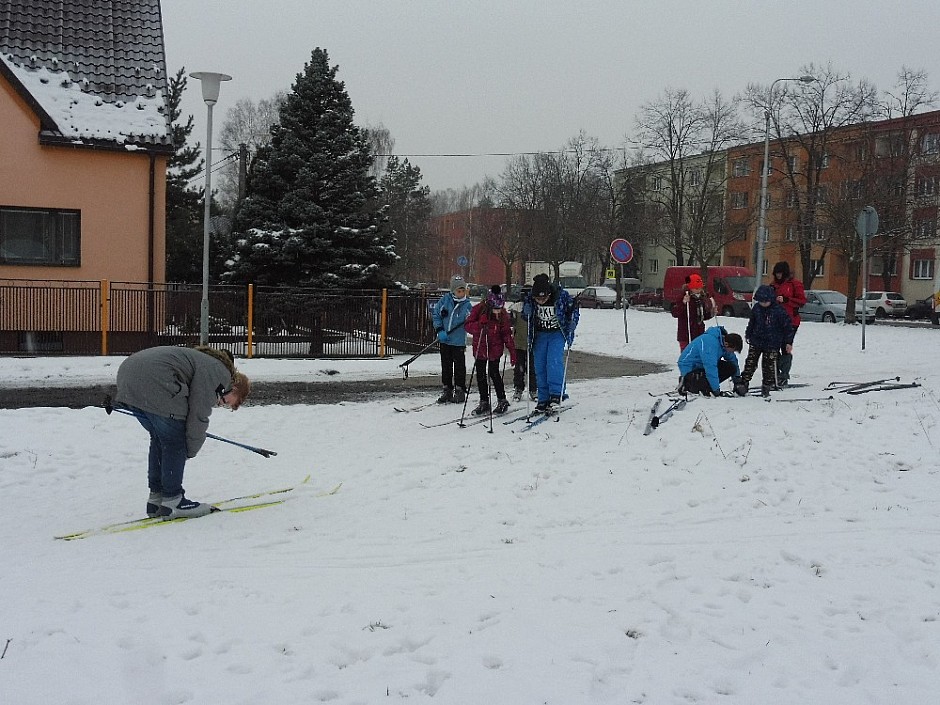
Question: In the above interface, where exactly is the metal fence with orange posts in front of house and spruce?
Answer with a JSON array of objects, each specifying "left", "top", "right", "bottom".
[{"left": 0, "top": 280, "right": 436, "bottom": 358}]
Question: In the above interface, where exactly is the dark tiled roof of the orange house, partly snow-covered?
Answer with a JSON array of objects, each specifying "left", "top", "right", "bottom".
[{"left": 0, "top": 0, "right": 172, "bottom": 151}]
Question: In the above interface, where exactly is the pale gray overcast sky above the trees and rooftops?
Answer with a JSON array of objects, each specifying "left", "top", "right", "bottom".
[{"left": 162, "top": 0, "right": 940, "bottom": 190}]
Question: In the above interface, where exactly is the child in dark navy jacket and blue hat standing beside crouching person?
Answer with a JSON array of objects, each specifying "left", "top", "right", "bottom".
[{"left": 741, "top": 284, "right": 794, "bottom": 396}]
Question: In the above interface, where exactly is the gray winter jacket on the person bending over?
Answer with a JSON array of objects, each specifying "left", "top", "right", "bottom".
[{"left": 115, "top": 346, "right": 232, "bottom": 458}]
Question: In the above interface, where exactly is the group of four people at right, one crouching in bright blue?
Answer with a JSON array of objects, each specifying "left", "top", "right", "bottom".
[{"left": 672, "top": 262, "right": 806, "bottom": 396}]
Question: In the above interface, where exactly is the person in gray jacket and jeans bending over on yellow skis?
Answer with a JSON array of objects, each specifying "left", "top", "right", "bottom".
[{"left": 115, "top": 346, "right": 250, "bottom": 519}]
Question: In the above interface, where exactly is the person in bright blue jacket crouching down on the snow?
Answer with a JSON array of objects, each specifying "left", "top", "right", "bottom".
[{"left": 679, "top": 326, "right": 747, "bottom": 397}]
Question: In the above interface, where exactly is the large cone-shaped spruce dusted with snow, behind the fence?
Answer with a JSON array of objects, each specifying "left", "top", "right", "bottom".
[{"left": 224, "top": 48, "right": 397, "bottom": 288}]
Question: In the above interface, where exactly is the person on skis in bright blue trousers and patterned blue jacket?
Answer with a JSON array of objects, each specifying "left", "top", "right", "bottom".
[{"left": 522, "top": 274, "right": 580, "bottom": 411}]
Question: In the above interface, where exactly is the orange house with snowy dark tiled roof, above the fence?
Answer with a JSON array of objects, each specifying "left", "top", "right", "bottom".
[{"left": 0, "top": 0, "right": 174, "bottom": 283}]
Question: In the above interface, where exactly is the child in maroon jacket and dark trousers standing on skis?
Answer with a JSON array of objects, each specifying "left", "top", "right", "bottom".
[{"left": 465, "top": 284, "right": 516, "bottom": 416}]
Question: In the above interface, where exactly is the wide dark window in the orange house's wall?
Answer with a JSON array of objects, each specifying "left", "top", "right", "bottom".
[{"left": 0, "top": 206, "right": 81, "bottom": 267}]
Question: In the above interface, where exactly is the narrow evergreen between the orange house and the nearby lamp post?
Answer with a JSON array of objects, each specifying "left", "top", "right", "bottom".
[{"left": 166, "top": 67, "right": 203, "bottom": 283}]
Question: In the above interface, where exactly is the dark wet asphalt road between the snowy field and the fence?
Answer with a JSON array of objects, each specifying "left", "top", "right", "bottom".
[{"left": 0, "top": 350, "right": 668, "bottom": 409}]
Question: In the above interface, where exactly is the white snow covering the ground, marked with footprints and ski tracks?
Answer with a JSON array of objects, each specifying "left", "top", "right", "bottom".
[{"left": 0, "top": 311, "right": 940, "bottom": 705}]
